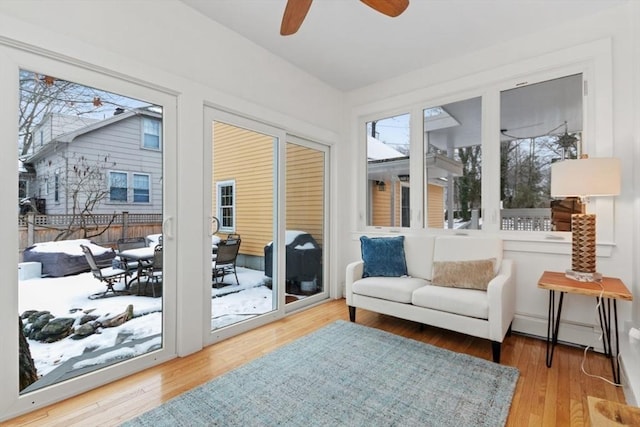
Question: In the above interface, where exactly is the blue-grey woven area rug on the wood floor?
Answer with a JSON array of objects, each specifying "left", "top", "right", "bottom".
[{"left": 124, "top": 320, "right": 519, "bottom": 427}]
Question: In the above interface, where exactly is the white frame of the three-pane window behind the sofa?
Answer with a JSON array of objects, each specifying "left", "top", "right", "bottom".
[{"left": 352, "top": 39, "right": 615, "bottom": 252}]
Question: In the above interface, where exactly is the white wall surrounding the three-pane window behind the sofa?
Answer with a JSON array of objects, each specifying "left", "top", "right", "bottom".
[{"left": 337, "top": 2, "right": 640, "bottom": 347}]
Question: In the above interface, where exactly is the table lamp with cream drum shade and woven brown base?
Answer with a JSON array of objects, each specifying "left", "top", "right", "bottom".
[{"left": 551, "top": 156, "right": 620, "bottom": 282}]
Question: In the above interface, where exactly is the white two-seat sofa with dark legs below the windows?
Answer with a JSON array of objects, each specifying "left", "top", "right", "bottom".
[{"left": 346, "top": 235, "right": 515, "bottom": 363}]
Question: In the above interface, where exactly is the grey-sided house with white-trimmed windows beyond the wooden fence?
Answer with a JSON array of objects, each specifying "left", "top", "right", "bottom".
[{"left": 21, "top": 109, "right": 162, "bottom": 214}]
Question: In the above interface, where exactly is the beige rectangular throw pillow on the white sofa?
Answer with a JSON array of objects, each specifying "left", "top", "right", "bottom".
[{"left": 431, "top": 258, "right": 496, "bottom": 291}]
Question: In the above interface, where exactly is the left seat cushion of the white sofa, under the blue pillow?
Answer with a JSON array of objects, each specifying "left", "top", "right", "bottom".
[{"left": 351, "top": 277, "right": 428, "bottom": 304}]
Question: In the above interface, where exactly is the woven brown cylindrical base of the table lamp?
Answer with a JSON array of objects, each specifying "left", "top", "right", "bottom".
[{"left": 566, "top": 214, "right": 602, "bottom": 282}]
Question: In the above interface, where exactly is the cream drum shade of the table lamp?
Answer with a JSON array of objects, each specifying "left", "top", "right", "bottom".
[{"left": 551, "top": 157, "right": 620, "bottom": 197}]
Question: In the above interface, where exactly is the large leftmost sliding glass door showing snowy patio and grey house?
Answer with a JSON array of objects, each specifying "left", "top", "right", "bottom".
[{"left": 0, "top": 46, "right": 176, "bottom": 422}]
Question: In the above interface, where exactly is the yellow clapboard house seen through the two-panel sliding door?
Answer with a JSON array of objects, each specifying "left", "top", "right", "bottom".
[{"left": 212, "top": 122, "right": 324, "bottom": 268}]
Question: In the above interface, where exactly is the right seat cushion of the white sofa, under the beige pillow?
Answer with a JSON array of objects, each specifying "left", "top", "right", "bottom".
[{"left": 411, "top": 285, "right": 489, "bottom": 319}]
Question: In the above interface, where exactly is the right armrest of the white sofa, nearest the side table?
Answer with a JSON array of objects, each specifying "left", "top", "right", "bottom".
[{"left": 487, "top": 259, "right": 516, "bottom": 342}]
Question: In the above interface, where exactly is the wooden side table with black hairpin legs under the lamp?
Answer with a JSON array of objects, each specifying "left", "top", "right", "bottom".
[{"left": 538, "top": 271, "right": 633, "bottom": 384}]
